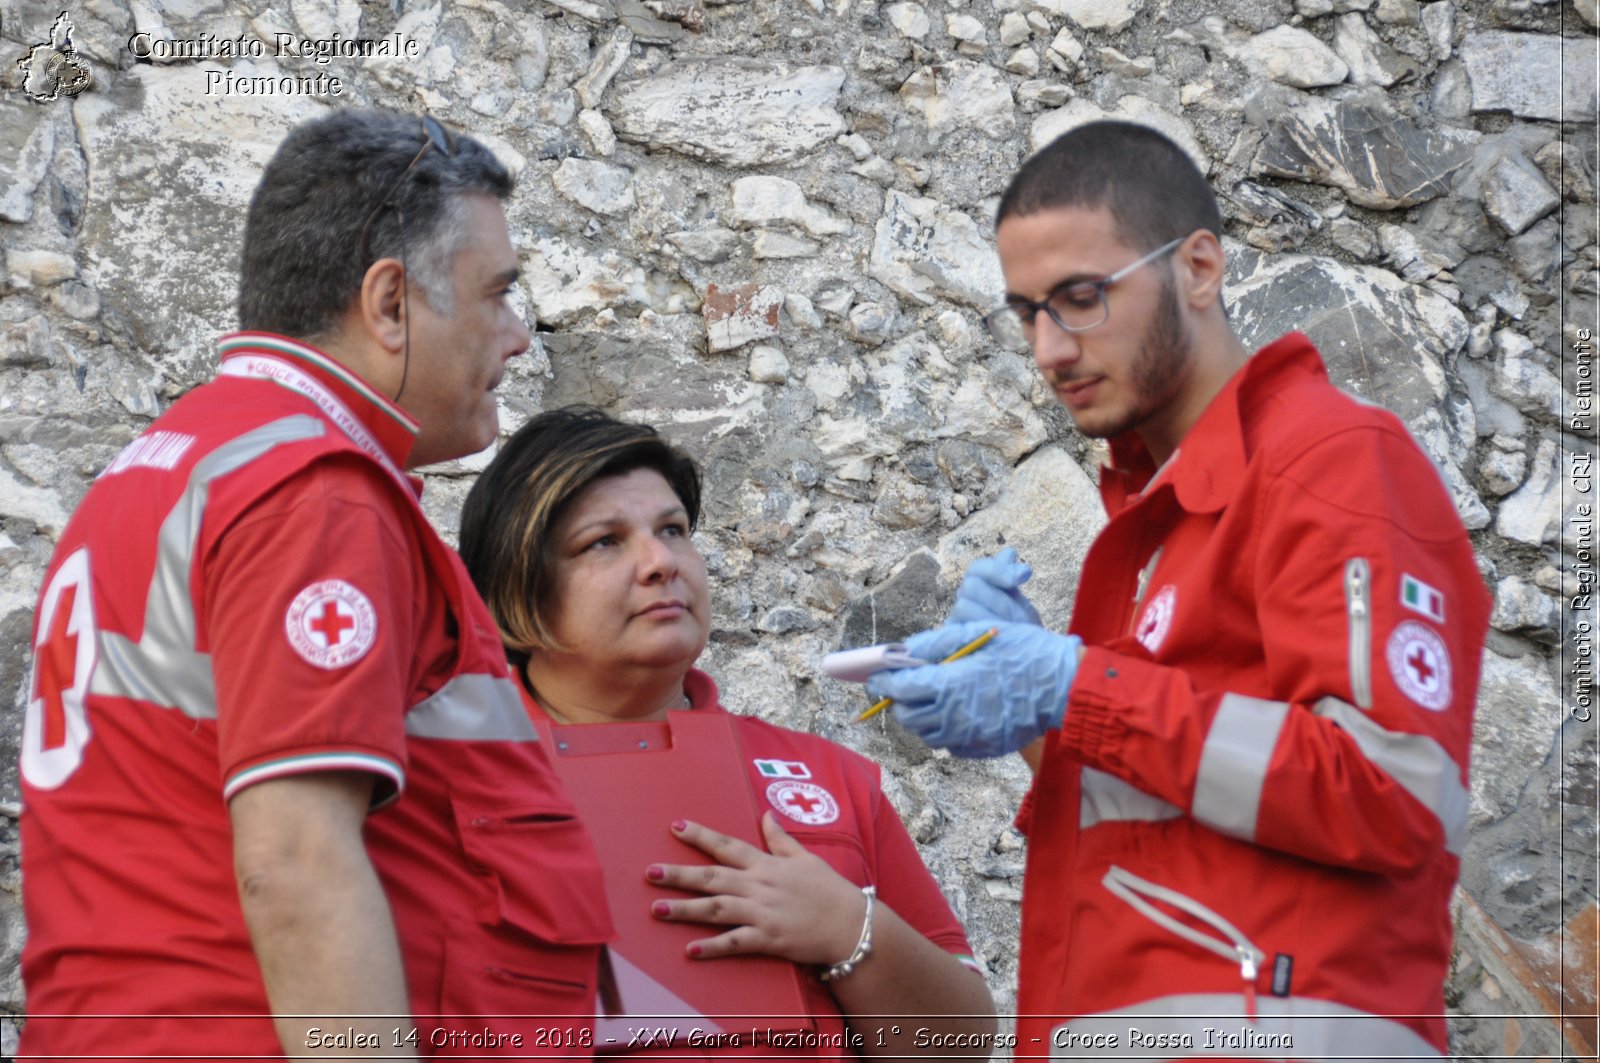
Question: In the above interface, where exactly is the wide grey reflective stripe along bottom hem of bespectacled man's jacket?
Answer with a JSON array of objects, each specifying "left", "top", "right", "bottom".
[{"left": 1050, "top": 993, "right": 1443, "bottom": 1061}]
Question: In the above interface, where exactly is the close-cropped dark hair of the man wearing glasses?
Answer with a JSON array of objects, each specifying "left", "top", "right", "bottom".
[{"left": 995, "top": 120, "right": 1222, "bottom": 251}]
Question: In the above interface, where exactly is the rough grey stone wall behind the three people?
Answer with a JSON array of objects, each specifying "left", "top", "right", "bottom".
[{"left": 0, "top": 0, "right": 1600, "bottom": 1055}]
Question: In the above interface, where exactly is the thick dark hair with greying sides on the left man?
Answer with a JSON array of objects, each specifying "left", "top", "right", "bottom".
[{"left": 238, "top": 107, "right": 512, "bottom": 339}]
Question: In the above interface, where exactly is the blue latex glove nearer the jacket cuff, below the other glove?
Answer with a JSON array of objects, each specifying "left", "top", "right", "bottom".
[{"left": 867, "top": 621, "right": 1083, "bottom": 757}]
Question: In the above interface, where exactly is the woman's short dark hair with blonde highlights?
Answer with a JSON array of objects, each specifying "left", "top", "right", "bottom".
[{"left": 461, "top": 407, "right": 701, "bottom": 668}]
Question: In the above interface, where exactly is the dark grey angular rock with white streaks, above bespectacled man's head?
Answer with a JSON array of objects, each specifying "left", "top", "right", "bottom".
[{"left": 1246, "top": 93, "right": 1478, "bottom": 210}]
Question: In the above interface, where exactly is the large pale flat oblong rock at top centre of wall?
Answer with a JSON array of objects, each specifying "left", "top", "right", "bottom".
[{"left": 608, "top": 59, "right": 845, "bottom": 166}]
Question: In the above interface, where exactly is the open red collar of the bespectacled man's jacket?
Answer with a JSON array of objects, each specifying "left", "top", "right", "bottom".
[{"left": 1101, "top": 331, "right": 1328, "bottom": 512}]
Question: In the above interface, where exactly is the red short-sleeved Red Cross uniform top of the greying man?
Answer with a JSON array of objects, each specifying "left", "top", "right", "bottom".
[{"left": 22, "top": 335, "right": 611, "bottom": 1057}]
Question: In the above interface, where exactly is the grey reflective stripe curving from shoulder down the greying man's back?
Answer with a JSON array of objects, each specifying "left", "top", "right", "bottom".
[{"left": 90, "top": 413, "right": 326, "bottom": 720}]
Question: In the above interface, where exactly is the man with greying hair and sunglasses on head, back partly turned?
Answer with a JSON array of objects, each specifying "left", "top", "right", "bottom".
[{"left": 21, "top": 110, "right": 611, "bottom": 1058}]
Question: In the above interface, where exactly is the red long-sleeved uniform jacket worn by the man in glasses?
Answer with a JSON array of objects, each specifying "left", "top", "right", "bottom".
[{"left": 1019, "top": 333, "right": 1490, "bottom": 1058}]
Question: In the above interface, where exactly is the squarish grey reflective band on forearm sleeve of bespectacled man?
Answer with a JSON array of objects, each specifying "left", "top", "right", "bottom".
[{"left": 1189, "top": 693, "right": 1290, "bottom": 842}]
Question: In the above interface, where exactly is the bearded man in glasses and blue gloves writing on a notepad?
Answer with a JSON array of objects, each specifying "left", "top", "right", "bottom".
[{"left": 869, "top": 122, "right": 1490, "bottom": 1058}]
